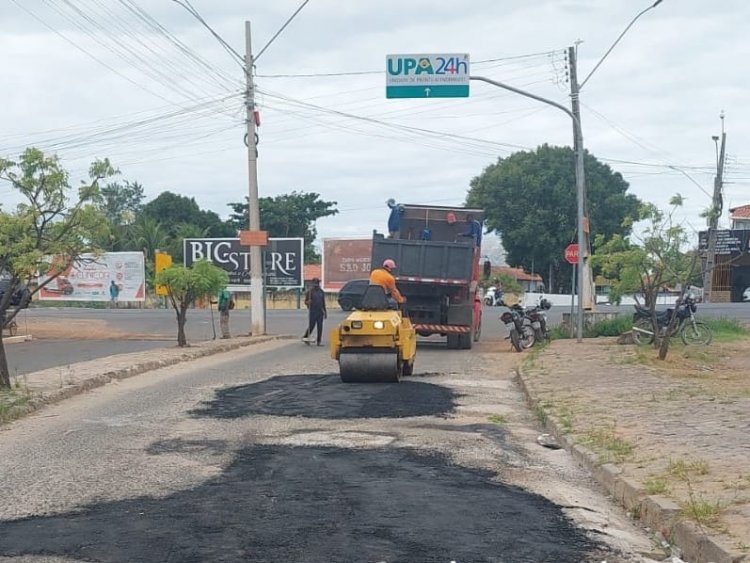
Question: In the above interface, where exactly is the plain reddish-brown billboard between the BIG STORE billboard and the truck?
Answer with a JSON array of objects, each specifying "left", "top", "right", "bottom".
[{"left": 322, "top": 238, "right": 372, "bottom": 291}]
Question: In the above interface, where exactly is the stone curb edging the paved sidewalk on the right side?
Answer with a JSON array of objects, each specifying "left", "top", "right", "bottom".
[{"left": 515, "top": 366, "right": 747, "bottom": 563}]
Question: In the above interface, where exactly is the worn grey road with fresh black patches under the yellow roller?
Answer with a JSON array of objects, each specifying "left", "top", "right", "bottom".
[{"left": 0, "top": 341, "right": 649, "bottom": 563}]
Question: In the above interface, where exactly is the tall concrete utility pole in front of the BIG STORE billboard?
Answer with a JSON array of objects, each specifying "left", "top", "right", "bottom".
[{"left": 245, "top": 21, "right": 266, "bottom": 336}]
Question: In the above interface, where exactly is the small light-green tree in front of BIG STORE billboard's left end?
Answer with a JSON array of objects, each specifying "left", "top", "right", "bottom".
[{"left": 156, "top": 260, "right": 229, "bottom": 348}]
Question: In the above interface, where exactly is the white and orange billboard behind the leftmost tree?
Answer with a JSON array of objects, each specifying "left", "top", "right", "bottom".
[{"left": 39, "top": 252, "right": 146, "bottom": 301}]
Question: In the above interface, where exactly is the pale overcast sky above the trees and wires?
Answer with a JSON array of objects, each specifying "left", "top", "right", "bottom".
[{"left": 0, "top": 0, "right": 750, "bottom": 258}]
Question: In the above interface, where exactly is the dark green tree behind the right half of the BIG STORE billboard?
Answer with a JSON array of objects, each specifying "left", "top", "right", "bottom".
[{"left": 228, "top": 191, "right": 338, "bottom": 264}]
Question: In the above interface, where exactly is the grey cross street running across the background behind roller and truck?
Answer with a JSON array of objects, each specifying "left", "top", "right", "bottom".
[{"left": 6, "top": 303, "right": 750, "bottom": 376}]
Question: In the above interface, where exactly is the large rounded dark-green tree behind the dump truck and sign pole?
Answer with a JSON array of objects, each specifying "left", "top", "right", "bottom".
[{"left": 466, "top": 145, "right": 640, "bottom": 291}]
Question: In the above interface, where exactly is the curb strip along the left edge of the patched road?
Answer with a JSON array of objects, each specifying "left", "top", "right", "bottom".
[{"left": 5, "top": 335, "right": 292, "bottom": 424}]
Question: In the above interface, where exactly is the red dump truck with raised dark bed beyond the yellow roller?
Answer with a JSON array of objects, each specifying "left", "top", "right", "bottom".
[{"left": 372, "top": 204, "right": 484, "bottom": 350}]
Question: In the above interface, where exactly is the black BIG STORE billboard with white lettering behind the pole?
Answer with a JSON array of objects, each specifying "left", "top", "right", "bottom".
[{"left": 183, "top": 238, "right": 305, "bottom": 291}]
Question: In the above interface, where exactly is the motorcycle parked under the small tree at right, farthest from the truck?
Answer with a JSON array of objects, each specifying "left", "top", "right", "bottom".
[{"left": 633, "top": 296, "right": 713, "bottom": 346}]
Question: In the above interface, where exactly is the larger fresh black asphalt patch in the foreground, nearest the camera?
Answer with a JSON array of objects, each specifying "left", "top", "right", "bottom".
[{"left": 0, "top": 444, "right": 601, "bottom": 563}]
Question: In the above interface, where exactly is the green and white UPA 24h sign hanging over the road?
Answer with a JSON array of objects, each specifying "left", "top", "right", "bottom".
[{"left": 385, "top": 53, "right": 469, "bottom": 98}]
